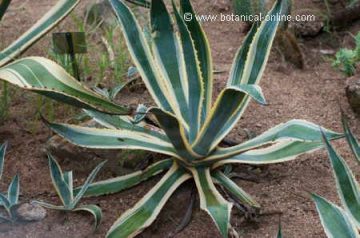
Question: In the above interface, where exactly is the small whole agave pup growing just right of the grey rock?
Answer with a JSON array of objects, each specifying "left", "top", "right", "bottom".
[{"left": 33, "top": 155, "right": 106, "bottom": 229}]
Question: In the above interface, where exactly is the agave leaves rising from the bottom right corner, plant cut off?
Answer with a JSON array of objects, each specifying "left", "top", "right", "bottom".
[{"left": 312, "top": 116, "right": 360, "bottom": 238}]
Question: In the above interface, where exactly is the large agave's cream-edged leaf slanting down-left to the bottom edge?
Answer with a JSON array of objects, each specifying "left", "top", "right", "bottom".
[{"left": 106, "top": 164, "right": 191, "bottom": 238}]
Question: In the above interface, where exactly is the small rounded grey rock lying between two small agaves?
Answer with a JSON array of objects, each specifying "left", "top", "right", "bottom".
[{"left": 15, "top": 203, "right": 46, "bottom": 222}]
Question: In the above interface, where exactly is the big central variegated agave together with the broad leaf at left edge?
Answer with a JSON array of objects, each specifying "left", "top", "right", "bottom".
[{"left": 0, "top": 0, "right": 341, "bottom": 238}]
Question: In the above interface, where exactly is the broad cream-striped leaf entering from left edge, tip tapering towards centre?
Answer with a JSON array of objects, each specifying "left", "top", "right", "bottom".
[{"left": 0, "top": 57, "right": 131, "bottom": 114}]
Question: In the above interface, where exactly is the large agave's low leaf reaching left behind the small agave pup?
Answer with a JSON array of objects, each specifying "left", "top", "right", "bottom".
[{"left": 74, "top": 159, "right": 173, "bottom": 197}]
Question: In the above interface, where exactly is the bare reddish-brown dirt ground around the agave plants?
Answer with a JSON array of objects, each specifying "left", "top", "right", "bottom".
[{"left": 0, "top": 0, "right": 360, "bottom": 238}]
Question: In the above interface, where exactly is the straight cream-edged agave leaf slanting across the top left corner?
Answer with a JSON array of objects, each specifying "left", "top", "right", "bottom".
[{"left": 0, "top": 0, "right": 80, "bottom": 67}]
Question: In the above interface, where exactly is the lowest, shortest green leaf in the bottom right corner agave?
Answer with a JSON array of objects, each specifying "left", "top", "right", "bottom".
[{"left": 312, "top": 194, "right": 359, "bottom": 238}]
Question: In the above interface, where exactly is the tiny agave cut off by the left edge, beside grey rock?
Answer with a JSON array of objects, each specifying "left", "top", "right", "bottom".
[{"left": 0, "top": 143, "right": 20, "bottom": 222}]
